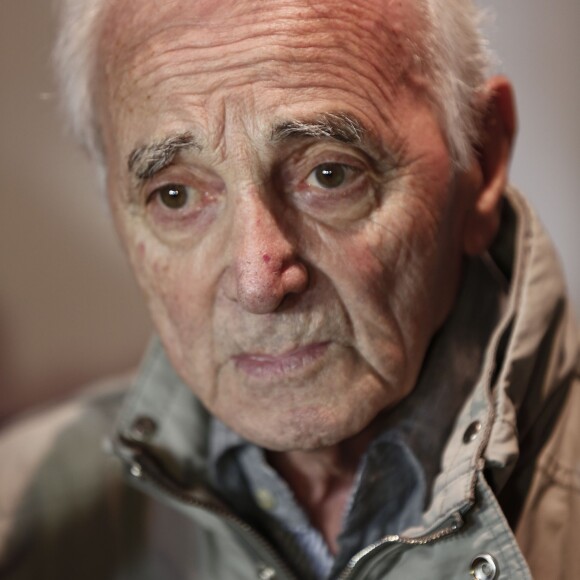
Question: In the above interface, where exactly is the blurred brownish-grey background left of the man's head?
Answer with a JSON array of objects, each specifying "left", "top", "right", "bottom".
[{"left": 0, "top": 0, "right": 150, "bottom": 417}]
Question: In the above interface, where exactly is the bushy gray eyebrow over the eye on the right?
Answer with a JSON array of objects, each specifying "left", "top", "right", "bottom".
[{"left": 272, "top": 113, "right": 367, "bottom": 145}]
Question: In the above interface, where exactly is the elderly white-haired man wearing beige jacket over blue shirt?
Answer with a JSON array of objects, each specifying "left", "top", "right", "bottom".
[{"left": 2, "top": 0, "right": 580, "bottom": 580}]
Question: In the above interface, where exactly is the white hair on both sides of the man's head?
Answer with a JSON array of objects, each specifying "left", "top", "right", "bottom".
[{"left": 55, "top": 0, "right": 489, "bottom": 170}]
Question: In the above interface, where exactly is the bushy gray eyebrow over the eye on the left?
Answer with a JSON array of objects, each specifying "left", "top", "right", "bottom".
[{"left": 127, "top": 132, "right": 201, "bottom": 180}]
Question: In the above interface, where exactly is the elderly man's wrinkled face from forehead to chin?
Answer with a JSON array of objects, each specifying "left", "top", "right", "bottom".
[{"left": 100, "top": 0, "right": 480, "bottom": 450}]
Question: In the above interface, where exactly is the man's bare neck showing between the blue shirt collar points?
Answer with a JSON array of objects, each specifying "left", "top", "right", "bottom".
[{"left": 267, "top": 416, "right": 386, "bottom": 554}]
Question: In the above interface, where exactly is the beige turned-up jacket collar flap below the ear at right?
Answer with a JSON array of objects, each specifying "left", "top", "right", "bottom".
[{"left": 485, "top": 188, "right": 579, "bottom": 490}]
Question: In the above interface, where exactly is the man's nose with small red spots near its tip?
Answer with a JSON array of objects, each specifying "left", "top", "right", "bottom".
[{"left": 226, "top": 195, "right": 308, "bottom": 314}]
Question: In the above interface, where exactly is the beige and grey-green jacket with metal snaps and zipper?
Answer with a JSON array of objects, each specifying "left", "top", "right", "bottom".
[{"left": 0, "top": 191, "right": 580, "bottom": 580}]
